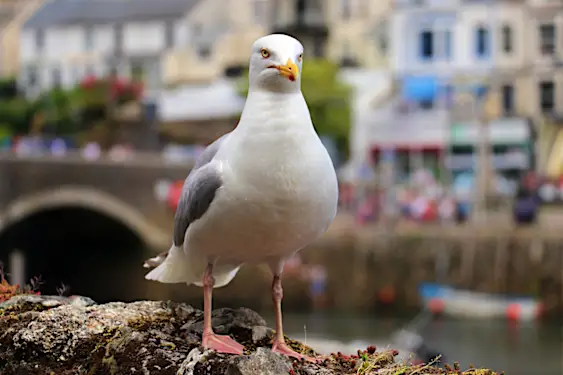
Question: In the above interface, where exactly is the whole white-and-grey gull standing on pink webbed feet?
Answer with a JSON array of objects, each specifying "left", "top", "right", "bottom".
[{"left": 145, "top": 34, "right": 338, "bottom": 359}]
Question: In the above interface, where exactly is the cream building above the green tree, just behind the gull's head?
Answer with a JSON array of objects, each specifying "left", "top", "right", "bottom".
[{"left": 269, "top": 0, "right": 391, "bottom": 68}]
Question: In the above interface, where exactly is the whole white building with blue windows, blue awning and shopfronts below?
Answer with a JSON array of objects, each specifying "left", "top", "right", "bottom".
[{"left": 353, "top": 0, "right": 530, "bottom": 182}]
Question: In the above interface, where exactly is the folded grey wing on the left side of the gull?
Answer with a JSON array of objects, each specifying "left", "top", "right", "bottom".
[{"left": 173, "top": 163, "right": 223, "bottom": 246}]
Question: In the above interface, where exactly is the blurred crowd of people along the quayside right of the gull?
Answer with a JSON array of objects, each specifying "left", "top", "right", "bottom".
[{"left": 340, "top": 165, "right": 546, "bottom": 225}]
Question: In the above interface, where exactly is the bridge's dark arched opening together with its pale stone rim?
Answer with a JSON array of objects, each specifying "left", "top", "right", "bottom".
[{"left": 0, "top": 186, "right": 166, "bottom": 302}]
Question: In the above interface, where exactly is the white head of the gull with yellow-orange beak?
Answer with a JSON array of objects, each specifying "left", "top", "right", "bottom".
[{"left": 249, "top": 34, "right": 303, "bottom": 92}]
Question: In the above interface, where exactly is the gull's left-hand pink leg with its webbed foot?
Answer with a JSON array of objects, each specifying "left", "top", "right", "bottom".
[{"left": 202, "top": 264, "right": 244, "bottom": 355}]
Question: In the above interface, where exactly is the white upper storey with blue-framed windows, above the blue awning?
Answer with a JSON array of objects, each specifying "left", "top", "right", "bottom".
[{"left": 390, "top": 0, "right": 526, "bottom": 77}]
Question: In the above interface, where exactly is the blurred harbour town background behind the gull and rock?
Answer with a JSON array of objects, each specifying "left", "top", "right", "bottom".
[{"left": 0, "top": 0, "right": 563, "bottom": 375}]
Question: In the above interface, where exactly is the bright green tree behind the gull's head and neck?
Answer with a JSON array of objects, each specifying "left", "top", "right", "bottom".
[{"left": 240, "top": 60, "right": 352, "bottom": 156}]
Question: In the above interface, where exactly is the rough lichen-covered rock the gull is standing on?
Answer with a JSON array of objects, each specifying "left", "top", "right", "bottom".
[{"left": 0, "top": 295, "right": 502, "bottom": 375}]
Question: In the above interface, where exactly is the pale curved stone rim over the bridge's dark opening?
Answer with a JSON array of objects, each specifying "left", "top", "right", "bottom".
[{"left": 0, "top": 186, "right": 165, "bottom": 248}]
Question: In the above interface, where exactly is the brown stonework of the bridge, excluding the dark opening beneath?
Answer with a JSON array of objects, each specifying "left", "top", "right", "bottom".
[{"left": 0, "top": 153, "right": 191, "bottom": 253}]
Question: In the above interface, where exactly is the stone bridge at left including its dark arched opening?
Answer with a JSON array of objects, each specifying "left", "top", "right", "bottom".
[{"left": 0, "top": 153, "right": 197, "bottom": 300}]
